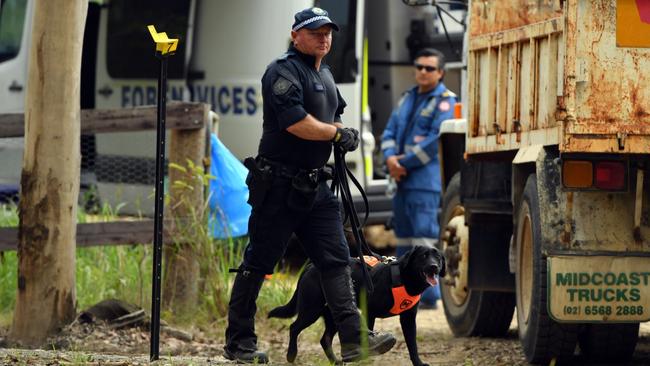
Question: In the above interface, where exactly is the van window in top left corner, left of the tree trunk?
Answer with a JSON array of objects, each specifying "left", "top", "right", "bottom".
[{"left": 0, "top": 0, "right": 27, "bottom": 62}]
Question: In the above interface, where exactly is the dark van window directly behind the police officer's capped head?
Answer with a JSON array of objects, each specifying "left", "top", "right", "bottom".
[{"left": 316, "top": 0, "right": 359, "bottom": 83}]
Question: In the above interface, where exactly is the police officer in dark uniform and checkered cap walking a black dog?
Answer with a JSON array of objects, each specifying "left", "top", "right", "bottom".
[{"left": 224, "top": 8, "right": 396, "bottom": 363}]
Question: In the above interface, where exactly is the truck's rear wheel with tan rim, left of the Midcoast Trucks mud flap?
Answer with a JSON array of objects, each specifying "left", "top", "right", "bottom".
[{"left": 515, "top": 174, "right": 579, "bottom": 363}]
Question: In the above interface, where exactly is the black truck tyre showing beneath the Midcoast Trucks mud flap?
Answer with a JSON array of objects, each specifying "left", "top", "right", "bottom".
[{"left": 578, "top": 323, "right": 639, "bottom": 363}]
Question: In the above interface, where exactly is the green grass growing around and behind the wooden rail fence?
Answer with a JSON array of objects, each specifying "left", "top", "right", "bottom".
[{"left": 0, "top": 205, "right": 297, "bottom": 331}]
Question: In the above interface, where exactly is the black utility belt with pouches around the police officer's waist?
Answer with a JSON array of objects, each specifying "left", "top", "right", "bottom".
[{"left": 244, "top": 156, "right": 333, "bottom": 212}]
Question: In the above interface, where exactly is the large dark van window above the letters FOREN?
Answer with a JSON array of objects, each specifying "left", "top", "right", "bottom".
[{"left": 95, "top": 0, "right": 194, "bottom": 108}]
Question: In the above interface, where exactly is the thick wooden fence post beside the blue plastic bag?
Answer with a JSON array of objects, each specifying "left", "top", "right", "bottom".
[{"left": 162, "top": 115, "right": 209, "bottom": 315}]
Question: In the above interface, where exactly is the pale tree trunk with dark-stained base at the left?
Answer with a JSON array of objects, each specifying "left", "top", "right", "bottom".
[{"left": 10, "top": 0, "right": 88, "bottom": 346}]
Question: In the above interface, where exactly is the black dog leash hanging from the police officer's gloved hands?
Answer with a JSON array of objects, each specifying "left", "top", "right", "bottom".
[{"left": 332, "top": 147, "right": 381, "bottom": 293}]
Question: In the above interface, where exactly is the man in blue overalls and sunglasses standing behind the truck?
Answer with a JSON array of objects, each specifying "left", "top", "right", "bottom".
[{"left": 381, "top": 48, "right": 456, "bottom": 307}]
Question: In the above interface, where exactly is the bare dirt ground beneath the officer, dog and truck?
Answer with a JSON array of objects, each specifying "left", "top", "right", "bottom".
[{"left": 0, "top": 309, "right": 650, "bottom": 366}]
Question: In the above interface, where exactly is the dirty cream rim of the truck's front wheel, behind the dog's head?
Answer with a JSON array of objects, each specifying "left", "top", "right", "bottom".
[{"left": 442, "top": 205, "right": 469, "bottom": 306}]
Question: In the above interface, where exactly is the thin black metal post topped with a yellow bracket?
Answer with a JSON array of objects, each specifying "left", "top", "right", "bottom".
[{"left": 147, "top": 25, "right": 178, "bottom": 361}]
